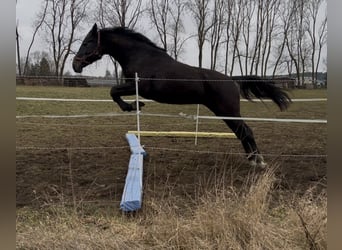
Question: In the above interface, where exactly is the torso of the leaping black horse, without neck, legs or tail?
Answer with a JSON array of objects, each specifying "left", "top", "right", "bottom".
[{"left": 139, "top": 55, "right": 240, "bottom": 112}]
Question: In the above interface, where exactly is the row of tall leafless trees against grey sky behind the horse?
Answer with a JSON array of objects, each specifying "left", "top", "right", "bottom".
[{"left": 16, "top": 0, "right": 327, "bottom": 86}]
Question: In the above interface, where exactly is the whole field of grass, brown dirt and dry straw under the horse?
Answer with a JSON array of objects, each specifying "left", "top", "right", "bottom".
[{"left": 16, "top": 86, "right": 327, "bottom": 249}]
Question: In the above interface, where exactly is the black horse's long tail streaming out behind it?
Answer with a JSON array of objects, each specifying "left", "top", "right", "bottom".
[{"left": 233, "top": 76, "right": 291, "bottom": 111}]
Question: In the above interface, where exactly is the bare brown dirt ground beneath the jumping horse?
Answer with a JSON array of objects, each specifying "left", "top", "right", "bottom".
[{"left": 16, "top": 87, "right": 327, "bottom": 209}]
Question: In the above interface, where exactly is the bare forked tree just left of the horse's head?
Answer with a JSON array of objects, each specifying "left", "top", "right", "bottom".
[{"left": 44, "top": 0, "right": 89, "bottom": 76}]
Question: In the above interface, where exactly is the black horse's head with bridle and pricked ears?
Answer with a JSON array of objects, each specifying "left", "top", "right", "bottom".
[{"left": 72, "top": 24, "right": 102, "bottom": 73}]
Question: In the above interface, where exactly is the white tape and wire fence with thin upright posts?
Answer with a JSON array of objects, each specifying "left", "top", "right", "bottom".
[{"left": 16, "top": 74, "right": 327, "bottom": 157}]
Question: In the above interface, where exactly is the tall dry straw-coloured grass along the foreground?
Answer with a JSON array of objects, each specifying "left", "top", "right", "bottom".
[{"left": 17, "top": 165, "right": 327, "bottom": 250}]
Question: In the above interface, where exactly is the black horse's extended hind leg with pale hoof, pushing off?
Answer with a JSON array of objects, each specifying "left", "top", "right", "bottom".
[{"left": 224, "top": 120, "right": 266, "bottom": 167}]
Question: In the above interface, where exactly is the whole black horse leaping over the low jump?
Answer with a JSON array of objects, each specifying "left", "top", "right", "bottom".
[{"left": 72, "top": 24, "right": 291, "bottom": 166}]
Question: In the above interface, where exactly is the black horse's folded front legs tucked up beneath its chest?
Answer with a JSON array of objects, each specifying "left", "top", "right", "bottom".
[{"left": 110, "top": 83, "right": 145, "bottom": 112}]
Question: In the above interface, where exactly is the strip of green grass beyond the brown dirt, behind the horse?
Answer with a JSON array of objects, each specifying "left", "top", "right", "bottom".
[{"left": 16, "top": 86, "right": 327, "bottom": 119}]
